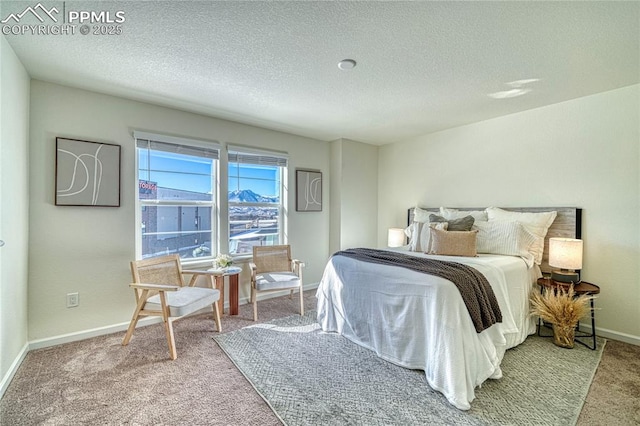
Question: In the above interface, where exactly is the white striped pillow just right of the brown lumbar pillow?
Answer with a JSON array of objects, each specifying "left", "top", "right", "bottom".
[{"left": 473, "top": 220, "right": 536, "bottom": 268}]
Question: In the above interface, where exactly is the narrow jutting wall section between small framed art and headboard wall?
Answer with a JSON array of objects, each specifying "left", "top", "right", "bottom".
[{"left": 331, "top": 139, "right": 386, "bottom": 252}]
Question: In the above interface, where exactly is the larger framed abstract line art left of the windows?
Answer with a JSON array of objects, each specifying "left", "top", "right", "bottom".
[{"left": 55, "top": 138, "right": 120, "bottom": 207}]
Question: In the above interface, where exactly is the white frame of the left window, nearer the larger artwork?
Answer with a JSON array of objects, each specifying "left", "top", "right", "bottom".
[{"left": 133, "top": 131, "right": 222, "bottom": 264}]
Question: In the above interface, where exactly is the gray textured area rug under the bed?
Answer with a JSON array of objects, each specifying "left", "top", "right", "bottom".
[{"left": 214, "top": 311, "right": 605, "bottom": 426}]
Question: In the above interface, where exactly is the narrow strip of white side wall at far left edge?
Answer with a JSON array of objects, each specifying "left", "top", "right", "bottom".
[{"left": 0, "top": 36, "right": 29, "bottom": 396}]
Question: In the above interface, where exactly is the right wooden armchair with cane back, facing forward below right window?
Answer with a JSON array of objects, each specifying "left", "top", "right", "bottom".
[{"left": 249, "top": 245, "right": 304, "bottom": 321}]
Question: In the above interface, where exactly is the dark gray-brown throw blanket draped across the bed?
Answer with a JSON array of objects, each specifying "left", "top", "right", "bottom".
[{"left": 334, "top": 248, "right": 502, "bottom": 333}]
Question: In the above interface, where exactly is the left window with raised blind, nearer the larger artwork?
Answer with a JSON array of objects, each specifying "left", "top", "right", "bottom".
[{"left": 134, "top": 132, "right": 220, "bottom": 259}]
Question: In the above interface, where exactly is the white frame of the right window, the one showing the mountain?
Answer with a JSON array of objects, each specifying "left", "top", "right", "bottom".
[{"left": 226, "top": 145, "right": 289, "bottom": 260}]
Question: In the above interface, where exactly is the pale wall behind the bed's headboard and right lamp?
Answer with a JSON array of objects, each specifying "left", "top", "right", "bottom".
[{"left": 378, "top": 85, "right": 640, "bottom": 344}]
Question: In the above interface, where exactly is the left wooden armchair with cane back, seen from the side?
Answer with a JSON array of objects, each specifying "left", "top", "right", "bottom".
[{"left": 122, "top": 254, "right": 222, "bottom": 359}]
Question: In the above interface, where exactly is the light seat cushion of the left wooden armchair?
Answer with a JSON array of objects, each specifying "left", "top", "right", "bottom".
[{"left": 144, "top": 287, "right": 220, "bottom": 317}]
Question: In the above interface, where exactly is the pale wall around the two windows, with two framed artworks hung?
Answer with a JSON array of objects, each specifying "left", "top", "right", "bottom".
[{"left": 29, "top": 80, "right": 329, "bottom": 340}]
